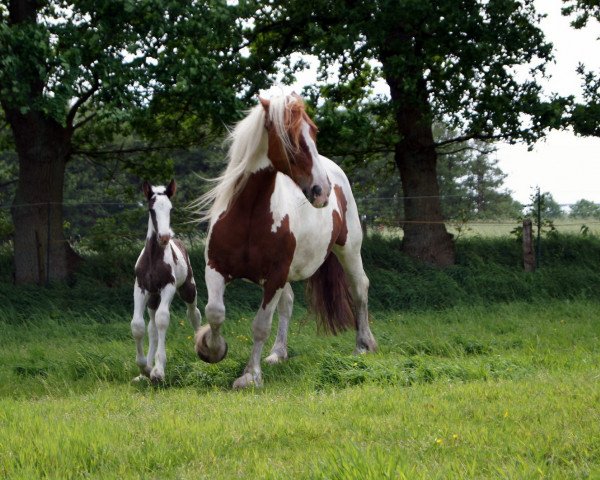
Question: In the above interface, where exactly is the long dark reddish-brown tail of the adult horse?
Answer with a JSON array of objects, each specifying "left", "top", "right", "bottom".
[{"left": 306, "top": 253, "right": 357, "bottom": 335}]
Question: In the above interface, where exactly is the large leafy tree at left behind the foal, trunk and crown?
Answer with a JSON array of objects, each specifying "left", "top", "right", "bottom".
[{"left": 0, "top": 0, "right": 262, "bottom": 283}]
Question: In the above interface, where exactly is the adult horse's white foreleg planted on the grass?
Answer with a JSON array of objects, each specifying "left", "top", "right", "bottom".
[{"left": 233, "top": 289, "right": 283, "bottom": 388}]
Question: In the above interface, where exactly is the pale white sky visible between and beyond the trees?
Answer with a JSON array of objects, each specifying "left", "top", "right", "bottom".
[{"left": 266, "top": 0, "right": 600, "bottom": 206}]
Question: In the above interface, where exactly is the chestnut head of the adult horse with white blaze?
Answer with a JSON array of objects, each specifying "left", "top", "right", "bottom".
[{"left": 259, "top": 94, "right": 331, "bottom": 208}]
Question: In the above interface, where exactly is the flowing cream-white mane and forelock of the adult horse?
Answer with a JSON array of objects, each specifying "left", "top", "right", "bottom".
[{"left": 192, "top": 95, "right": 312, "bottom": 222}]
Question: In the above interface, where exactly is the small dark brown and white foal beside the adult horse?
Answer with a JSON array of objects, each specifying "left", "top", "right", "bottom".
[{"left": 131, "top": 180, "right": 201, "bottom": 382}]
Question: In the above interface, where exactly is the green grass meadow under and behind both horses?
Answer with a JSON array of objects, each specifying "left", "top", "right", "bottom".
[{"left": 0, "top": 236, "right": 600, "bottom": 479}]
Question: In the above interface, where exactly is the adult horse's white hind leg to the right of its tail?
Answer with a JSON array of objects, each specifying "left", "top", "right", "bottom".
[{"left": 333, "top": 247, "right": 377, "bottom": 353}]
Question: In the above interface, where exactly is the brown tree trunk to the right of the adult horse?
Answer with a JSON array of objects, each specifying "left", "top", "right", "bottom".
[{"left": 384, "top": 74, "right": 454, "bottom": 266}]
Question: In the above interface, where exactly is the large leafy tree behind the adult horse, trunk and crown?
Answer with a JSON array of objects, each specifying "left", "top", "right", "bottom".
[{"left": 248, "top": 0, "right": 567, "bottom": 265}]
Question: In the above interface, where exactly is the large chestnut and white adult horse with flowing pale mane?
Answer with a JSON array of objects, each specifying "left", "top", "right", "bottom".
[{"left": 196, "top": 95, "right": 377, "bottom": 388}]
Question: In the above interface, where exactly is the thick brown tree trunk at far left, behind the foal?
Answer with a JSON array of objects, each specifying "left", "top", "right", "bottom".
[{"left": 5, "top": 108, "right": 79, "bottom": 284}]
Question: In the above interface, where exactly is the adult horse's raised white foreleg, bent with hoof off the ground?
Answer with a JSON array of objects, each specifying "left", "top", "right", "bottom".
[{"left": 196, "top": 266, "right": 227, "bottom": 363}]
